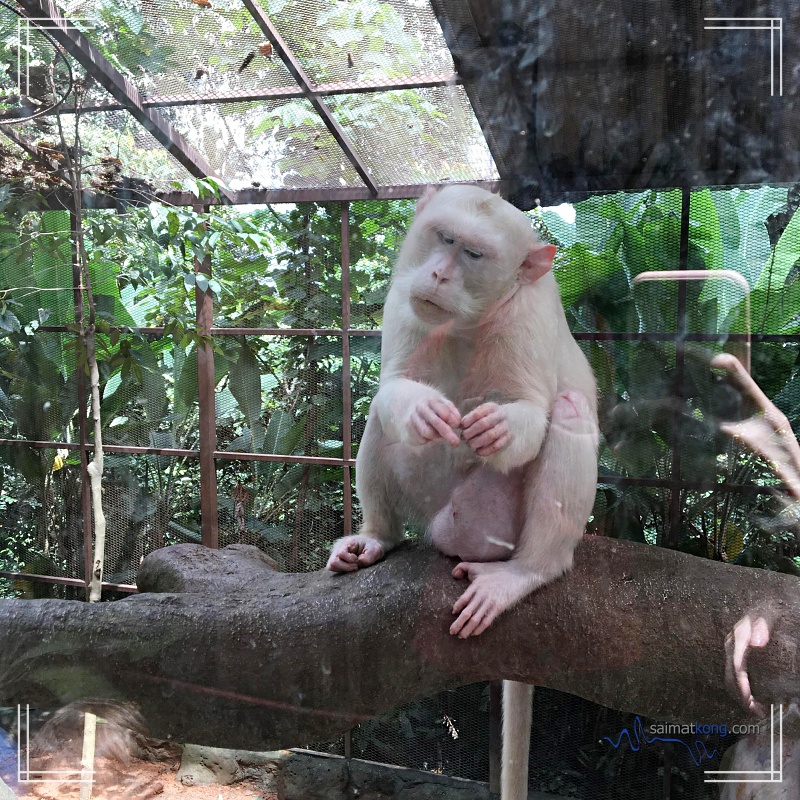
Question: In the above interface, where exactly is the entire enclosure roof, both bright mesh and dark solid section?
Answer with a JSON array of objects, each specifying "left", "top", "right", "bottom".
[{"left": 0, "top": 0, "right": 800, "bottom": 207}]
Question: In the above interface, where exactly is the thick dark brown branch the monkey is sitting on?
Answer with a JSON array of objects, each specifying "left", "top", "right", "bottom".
[{"left": 0, "top": 537, "right": 800, "bottom": 749}]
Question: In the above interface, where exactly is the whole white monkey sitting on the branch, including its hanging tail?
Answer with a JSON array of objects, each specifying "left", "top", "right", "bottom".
[{"left": 328, "top": 185, "right": 598, "bottom": 800}]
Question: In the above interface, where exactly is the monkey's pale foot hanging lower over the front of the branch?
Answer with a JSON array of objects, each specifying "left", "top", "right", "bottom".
[{"left": 450, "top": 561, "right": 539, "bottom": 639}]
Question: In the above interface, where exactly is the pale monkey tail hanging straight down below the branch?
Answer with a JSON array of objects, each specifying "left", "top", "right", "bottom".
[{"left": 500, "top": 681, "right": 533, "bottom": 800}]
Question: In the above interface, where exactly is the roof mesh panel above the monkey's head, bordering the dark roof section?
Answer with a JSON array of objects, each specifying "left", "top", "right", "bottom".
[{"left": 328, "top": 86, "right": 497, "bottom": 185}]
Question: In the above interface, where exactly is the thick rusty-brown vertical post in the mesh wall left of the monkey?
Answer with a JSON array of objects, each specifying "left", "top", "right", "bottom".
[{"left": 194, "top": 206, "right": 219, "bottom": 548}]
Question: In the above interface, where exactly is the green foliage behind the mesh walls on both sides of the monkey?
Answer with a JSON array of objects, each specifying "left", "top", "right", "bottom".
[{"left": 0, "top": 183, "right": 800, "bottom": 580}]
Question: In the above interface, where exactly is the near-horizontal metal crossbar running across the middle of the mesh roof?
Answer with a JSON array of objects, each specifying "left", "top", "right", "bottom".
[{"left": 17, "top": 72, "right": 462, "bottom": 115}]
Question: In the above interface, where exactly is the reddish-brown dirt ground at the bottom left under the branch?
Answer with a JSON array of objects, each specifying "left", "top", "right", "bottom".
[{"left": 16, "top": 761, "right": 277, "bottom": 800}]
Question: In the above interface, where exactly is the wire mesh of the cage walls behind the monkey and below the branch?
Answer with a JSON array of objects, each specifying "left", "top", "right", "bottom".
[{"left": 0, "top": 181, "right": 800, "bottom": 800}]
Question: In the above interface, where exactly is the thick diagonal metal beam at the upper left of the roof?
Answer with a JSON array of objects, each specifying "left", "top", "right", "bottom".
[{"left": 14, "top": 0, "right": 227, "bottom": 196}]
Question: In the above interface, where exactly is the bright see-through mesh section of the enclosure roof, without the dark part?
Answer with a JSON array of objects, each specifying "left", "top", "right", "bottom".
[{"left": 0, "top": 0, "right": 498, "bottom": 202}]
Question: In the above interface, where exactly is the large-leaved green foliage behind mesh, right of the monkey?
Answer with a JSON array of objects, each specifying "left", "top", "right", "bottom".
[{"left": 539, "top": 186, "right": 800, "bottom": 571}]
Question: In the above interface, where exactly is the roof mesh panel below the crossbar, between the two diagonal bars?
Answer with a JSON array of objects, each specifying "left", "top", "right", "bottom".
[{"left": 160, "top": 99, "right": 363, "bottom": 189}]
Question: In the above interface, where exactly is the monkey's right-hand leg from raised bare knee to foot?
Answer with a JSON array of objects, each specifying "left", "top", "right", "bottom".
[{"left": 450, "top": 391, "right": 597, "bottom": 638}]
